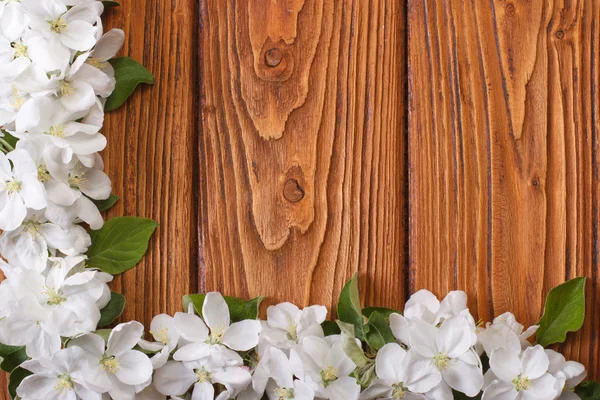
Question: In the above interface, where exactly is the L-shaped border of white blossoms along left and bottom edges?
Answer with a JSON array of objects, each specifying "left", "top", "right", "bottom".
[{"left": 0, "top": 0, "right": 586, "bottom": 400}]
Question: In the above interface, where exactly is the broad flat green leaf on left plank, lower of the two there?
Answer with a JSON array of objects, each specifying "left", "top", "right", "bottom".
[{"left": 87, "top": 217, "right": 158, "bottom": 275}]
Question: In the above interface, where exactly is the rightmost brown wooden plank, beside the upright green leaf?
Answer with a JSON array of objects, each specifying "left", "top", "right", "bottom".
[{"left": 408, "top": 0, "right": 600, "bottom": 378}]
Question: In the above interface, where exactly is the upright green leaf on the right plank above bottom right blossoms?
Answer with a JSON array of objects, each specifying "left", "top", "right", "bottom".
[{"left": 536, "top": 278, "right": 585, "bottom": 347}]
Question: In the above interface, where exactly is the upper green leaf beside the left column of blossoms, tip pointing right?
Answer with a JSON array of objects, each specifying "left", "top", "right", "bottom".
[{"left": 104, "top": 57, "right": 154, "bottom": 112}]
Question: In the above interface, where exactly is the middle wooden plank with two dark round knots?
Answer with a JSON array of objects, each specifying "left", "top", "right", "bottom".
[{"left": 200, "top": 0, "right": 406, "bottom": 307}]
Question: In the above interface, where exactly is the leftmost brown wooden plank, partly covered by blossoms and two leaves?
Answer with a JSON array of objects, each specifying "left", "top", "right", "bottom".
[{"left": 103, "top": 0, "right": 198, "bottom": 326}]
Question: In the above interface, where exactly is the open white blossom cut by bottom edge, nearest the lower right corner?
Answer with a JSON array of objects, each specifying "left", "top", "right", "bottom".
[{"left": 482, "top": 345, "right": 560, "bottom": 400}]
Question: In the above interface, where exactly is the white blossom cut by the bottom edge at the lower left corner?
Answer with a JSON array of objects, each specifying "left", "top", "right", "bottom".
[{"left": 17, "top": 347, "right": 101, "bottom": 400}]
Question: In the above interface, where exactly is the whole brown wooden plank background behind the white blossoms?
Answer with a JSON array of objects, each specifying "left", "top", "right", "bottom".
[{"left": 1, "top": 0, "right": 600, "bottom": 394}]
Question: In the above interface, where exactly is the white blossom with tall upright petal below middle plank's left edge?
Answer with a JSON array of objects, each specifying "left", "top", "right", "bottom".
[{"left": 173, "top": 292, "right": 261, "bottom": 365}]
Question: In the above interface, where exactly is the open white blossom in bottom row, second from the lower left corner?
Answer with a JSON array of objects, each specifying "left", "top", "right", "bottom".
[{"left": 69, "top": 321, "right": 152, "bottom": 399}]
